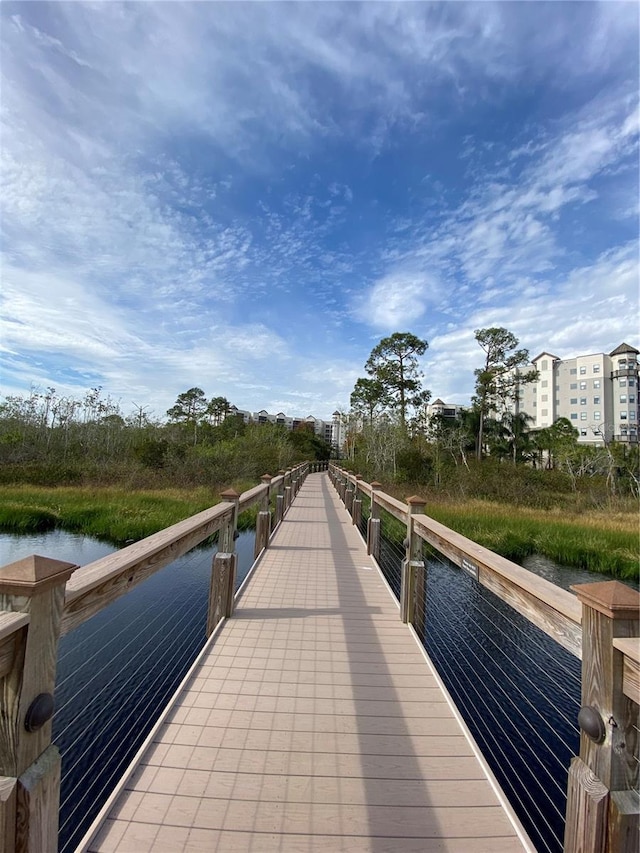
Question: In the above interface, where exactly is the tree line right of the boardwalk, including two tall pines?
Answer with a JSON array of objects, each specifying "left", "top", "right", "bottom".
[{"left": 342, "top": 327, "right": 639, "bottom": 496}]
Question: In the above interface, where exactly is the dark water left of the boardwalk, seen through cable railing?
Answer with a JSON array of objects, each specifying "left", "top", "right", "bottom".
[{"left": 0, "top": 531, "right": 254, "bottom": 853}]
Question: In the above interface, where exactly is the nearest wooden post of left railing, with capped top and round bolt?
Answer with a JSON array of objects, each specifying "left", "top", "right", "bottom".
[{"left": 0, "top": 556, "right": 77, "bottom": 853}]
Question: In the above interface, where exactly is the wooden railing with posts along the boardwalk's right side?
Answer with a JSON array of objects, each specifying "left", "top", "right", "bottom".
[{"left": 329, "top": 464, "right": 640, "bottom": 853}]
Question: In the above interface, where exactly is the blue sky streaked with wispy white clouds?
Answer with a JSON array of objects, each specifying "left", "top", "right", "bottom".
[{"left": 0, "top": 2, "right": 640, "bottom": 417}]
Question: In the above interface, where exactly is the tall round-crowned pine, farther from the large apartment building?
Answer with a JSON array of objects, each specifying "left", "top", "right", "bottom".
[{"left": 365, "top": 332, "right": 431, "bottom": 428}]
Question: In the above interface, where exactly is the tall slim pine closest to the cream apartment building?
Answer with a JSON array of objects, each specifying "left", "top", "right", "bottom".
[{"left": 473, "top": 326, "right": 538, "bottom": 459}]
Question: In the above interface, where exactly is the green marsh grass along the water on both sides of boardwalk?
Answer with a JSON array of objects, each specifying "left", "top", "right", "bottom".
[{"left": 0, "top": 482, "right": 640, "bottom": 581}]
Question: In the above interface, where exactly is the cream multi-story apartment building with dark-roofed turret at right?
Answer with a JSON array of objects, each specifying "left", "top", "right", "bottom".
[{"left": 513, "top": 343, "right": 640, "bottom": 444}]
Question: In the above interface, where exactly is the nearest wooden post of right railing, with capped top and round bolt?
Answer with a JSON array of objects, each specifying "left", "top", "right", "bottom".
[{"left": 564, "top": 581, "right": 640, "bottom": 853}]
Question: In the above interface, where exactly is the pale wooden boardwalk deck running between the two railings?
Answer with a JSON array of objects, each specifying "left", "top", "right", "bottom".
[{"left": 82, "top": 474, "right": 533, "bottom": 853}]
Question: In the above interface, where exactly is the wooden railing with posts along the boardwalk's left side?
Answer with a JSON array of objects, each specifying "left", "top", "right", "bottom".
[{"left": 0, "top": 463, "right": 310, "bottom": 853}]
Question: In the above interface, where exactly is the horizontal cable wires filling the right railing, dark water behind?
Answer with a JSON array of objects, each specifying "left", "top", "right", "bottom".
[{"left": 364, "top": 502, "right": 580, "bottom": 853}]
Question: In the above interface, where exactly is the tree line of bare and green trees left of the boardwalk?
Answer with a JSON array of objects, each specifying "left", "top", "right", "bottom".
[{"left": 0, "top": 387, "right": 331, "bottom": 485}]
